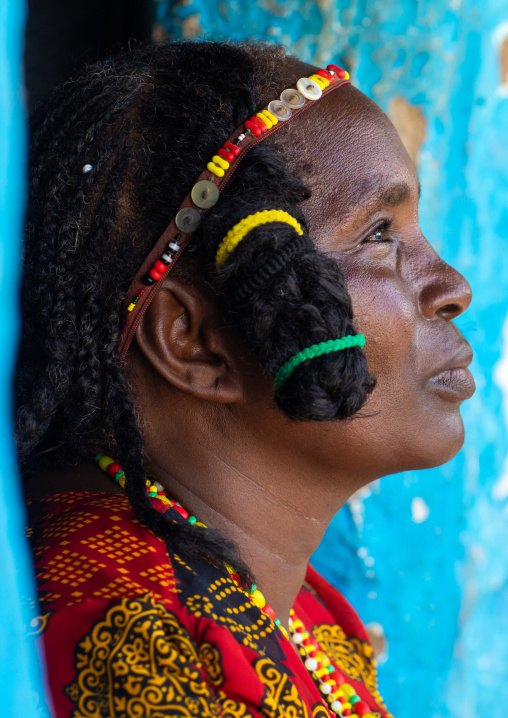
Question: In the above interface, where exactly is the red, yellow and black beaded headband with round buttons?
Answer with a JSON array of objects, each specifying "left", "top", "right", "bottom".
[{"left": 118, "top": 65, "right": 351, "bottom": 362}]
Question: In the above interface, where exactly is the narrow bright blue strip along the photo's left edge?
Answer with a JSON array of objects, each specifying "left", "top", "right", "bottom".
[{"left": 0, "top": 0, "right": 49, "bottom": 718}]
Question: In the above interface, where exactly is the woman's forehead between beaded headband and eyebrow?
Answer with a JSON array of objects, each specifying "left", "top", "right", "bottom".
[{"left": 275, "top": 80, "right": 418, "bottom": 233}]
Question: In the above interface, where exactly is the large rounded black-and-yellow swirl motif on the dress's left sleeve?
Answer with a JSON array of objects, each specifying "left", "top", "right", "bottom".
[{"left": 65, "top": 594, "right": 224, "bottom": 718}]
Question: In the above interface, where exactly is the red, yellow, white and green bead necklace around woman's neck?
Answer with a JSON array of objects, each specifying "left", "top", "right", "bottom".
[{"left": 95, "top": 452, "right": 375, "bottom": 718}]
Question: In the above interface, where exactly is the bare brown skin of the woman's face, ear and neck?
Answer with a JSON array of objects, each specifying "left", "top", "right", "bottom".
[{"left": 23, "top": 71, "right": 474, "bottom": 624}]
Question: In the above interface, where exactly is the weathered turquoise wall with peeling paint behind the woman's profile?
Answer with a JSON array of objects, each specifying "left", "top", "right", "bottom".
[{"left": 156, "top": 0, "right": 508, "bottom": 718}]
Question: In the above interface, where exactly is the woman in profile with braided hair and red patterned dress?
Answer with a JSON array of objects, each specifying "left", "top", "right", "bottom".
[{"left": 16, "top": 43, "right": 474, "bottom": 717}]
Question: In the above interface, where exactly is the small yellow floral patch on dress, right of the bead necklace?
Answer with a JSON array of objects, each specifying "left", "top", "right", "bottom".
[{"left": 312, "top": 623, "right": 392, "bottom": 718}]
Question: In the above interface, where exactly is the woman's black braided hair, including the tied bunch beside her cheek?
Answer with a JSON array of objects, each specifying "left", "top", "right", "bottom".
[{"left": 16, "top": 42, "right": 374, "bottom": 582}]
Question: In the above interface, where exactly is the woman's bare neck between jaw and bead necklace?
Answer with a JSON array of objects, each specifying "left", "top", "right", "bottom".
[{"left": 147, "top": 414, "right": 352, "bottom": 626}]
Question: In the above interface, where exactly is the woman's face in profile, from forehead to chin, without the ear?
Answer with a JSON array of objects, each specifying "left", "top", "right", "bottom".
[{"left": 270, "top": 80, "right": 474, "bottom": 476}]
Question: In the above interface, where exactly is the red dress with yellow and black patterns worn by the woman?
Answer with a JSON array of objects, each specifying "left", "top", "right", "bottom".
[{"left": 29, "top": 492, "right": 390, "bottom": 718}]
